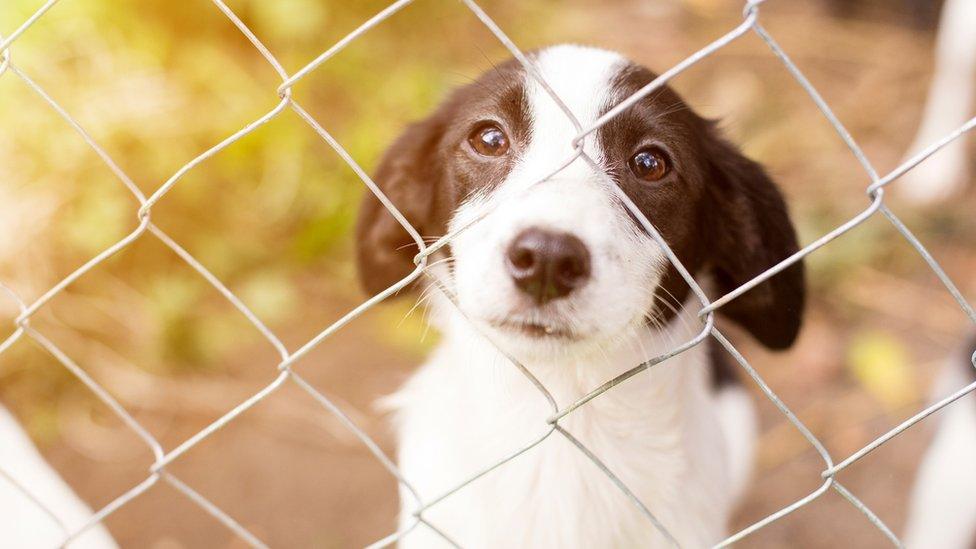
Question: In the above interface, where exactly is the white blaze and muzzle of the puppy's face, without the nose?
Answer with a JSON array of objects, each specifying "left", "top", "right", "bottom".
[{"left": 450, "top": 46, "right": 664, "bottom": 351}]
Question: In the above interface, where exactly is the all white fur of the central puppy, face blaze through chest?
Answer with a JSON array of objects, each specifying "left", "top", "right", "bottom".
[{"left": 388, "top": 46, "right": 755, "bottom": 548}]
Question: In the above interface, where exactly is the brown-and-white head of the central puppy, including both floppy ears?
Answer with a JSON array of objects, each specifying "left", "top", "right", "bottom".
[{"left": 358, "top": 46, "right": 804, "bottom": 355}]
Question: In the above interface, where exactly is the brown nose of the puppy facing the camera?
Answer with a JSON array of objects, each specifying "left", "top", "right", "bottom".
[{"left": 506, "top": 229, "right": 590, "bottom": 305}]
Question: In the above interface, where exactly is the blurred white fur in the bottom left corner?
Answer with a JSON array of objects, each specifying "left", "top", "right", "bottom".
[{"left": 0, "top": 400, "right": 116, "bottom": 549}]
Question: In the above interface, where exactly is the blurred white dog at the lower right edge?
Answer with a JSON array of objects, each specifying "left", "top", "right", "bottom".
[{"left": 903, "top": 337, "right": 976, "bottom": 549}]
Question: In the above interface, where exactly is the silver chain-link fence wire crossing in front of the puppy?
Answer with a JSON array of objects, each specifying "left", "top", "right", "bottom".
[{"left": 0, "top": 0, "right": 976, "bottom": 547}]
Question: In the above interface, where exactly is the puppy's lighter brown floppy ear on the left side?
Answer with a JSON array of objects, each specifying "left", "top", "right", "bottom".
[{"left": 356, "top": 117, "right": 443, "bottom": 294}]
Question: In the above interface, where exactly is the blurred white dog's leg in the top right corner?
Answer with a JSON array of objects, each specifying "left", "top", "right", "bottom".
[{"left": 899, "top": 0, "right": 976, "bottom": 204}]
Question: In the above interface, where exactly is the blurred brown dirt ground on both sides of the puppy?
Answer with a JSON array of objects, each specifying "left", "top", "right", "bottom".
[{"left": 1, "top": 2, "right": 976, "bottom": 549}]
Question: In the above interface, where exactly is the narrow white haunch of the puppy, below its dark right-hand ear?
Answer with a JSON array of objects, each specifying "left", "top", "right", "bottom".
[{"left": 715, "top": 384, "right": 759, "bottom": 503}]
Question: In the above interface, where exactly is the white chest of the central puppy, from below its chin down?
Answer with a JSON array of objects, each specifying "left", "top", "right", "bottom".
[{"left": 389, "top": 302, "right": 735, "bottom": 548}]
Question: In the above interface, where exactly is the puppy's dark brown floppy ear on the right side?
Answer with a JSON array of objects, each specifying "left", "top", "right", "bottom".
[{"left": 704, "top": 128, "right": 806, "bottom": 349}]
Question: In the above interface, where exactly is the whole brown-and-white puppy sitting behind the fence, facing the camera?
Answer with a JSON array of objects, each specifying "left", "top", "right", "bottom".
[{"left": 356, "top": 45, "right": 805, "bottom": 548}]
